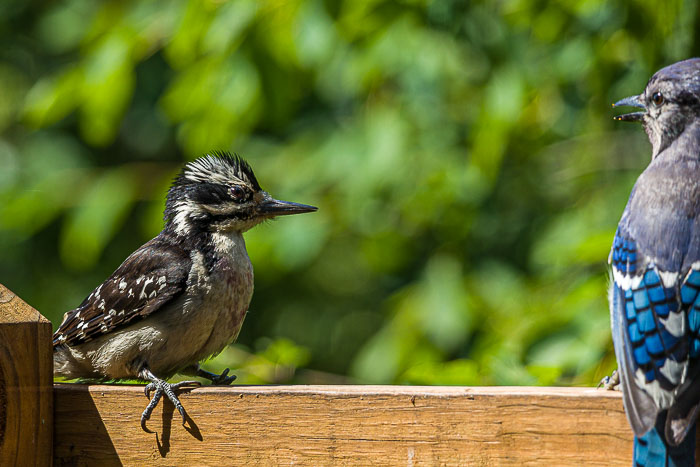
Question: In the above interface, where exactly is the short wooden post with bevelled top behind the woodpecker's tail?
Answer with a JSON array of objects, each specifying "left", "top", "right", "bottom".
[{"left": 0, "top": 284, "right": 53, "bottom": 465}]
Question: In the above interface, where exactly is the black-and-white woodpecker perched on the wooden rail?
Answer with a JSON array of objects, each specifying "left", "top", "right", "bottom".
[{"left": 53, "top": 153, "right": 317, "bottom": 431}]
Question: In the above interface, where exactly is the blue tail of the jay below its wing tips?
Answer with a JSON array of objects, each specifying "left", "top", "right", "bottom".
[{"left": 634, "top": 414, "right": 696, "bottom": 467}]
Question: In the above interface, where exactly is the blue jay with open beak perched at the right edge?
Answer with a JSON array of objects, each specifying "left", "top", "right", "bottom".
[{"left": 609, "top": 58, "right": 700, "bottom": 466}]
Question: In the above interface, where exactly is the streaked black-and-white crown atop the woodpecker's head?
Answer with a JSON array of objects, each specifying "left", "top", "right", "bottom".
[{"left": 175, "top": 152, "right": 260, "bottom": 191}]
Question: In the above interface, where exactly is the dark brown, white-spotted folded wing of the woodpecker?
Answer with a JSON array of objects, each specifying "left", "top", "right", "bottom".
[{"left": 53, "top": 237, "right": 191, "bottom": 346}]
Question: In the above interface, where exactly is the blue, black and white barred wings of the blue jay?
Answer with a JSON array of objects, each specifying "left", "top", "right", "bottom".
[{"left": 610, "top": 230, "right": 700, "bottom": 452}]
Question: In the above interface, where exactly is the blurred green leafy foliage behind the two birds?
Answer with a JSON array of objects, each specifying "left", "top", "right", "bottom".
[{"left": 0, "top": 0, "right": 699, "bottom": 385}]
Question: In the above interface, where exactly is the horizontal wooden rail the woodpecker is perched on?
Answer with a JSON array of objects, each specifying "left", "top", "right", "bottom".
[{"left": 54, "top": 384, "right": 632, "bottom": 466}]
